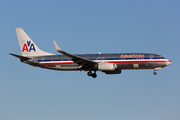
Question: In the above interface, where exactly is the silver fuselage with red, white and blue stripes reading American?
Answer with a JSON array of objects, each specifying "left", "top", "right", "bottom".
[{"left": 33, "top": 53, "right": 171, "bottom": 71}]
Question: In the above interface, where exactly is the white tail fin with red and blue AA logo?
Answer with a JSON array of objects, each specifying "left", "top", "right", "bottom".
[{"left": 16, "top": 28, "right": 53, "bottom": 57}]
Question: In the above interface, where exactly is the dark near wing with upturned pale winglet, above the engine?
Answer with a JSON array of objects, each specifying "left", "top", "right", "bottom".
[{"left": 53, "top": 41, "right": 98, "bottom": 67}]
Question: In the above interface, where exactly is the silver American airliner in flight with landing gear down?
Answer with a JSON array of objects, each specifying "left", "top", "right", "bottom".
[{"left": 9, "top": 28, "right": 171, "bottom": 78}]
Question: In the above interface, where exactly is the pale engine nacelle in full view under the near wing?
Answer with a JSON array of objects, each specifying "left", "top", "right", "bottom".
[{"left": 98, "top": 63, "right": 117, "bottom": 71}]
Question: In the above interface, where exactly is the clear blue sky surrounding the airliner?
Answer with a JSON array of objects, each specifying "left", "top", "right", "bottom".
[{"left": 0, "top": 0, "right": 180, "bottom": 120}]
